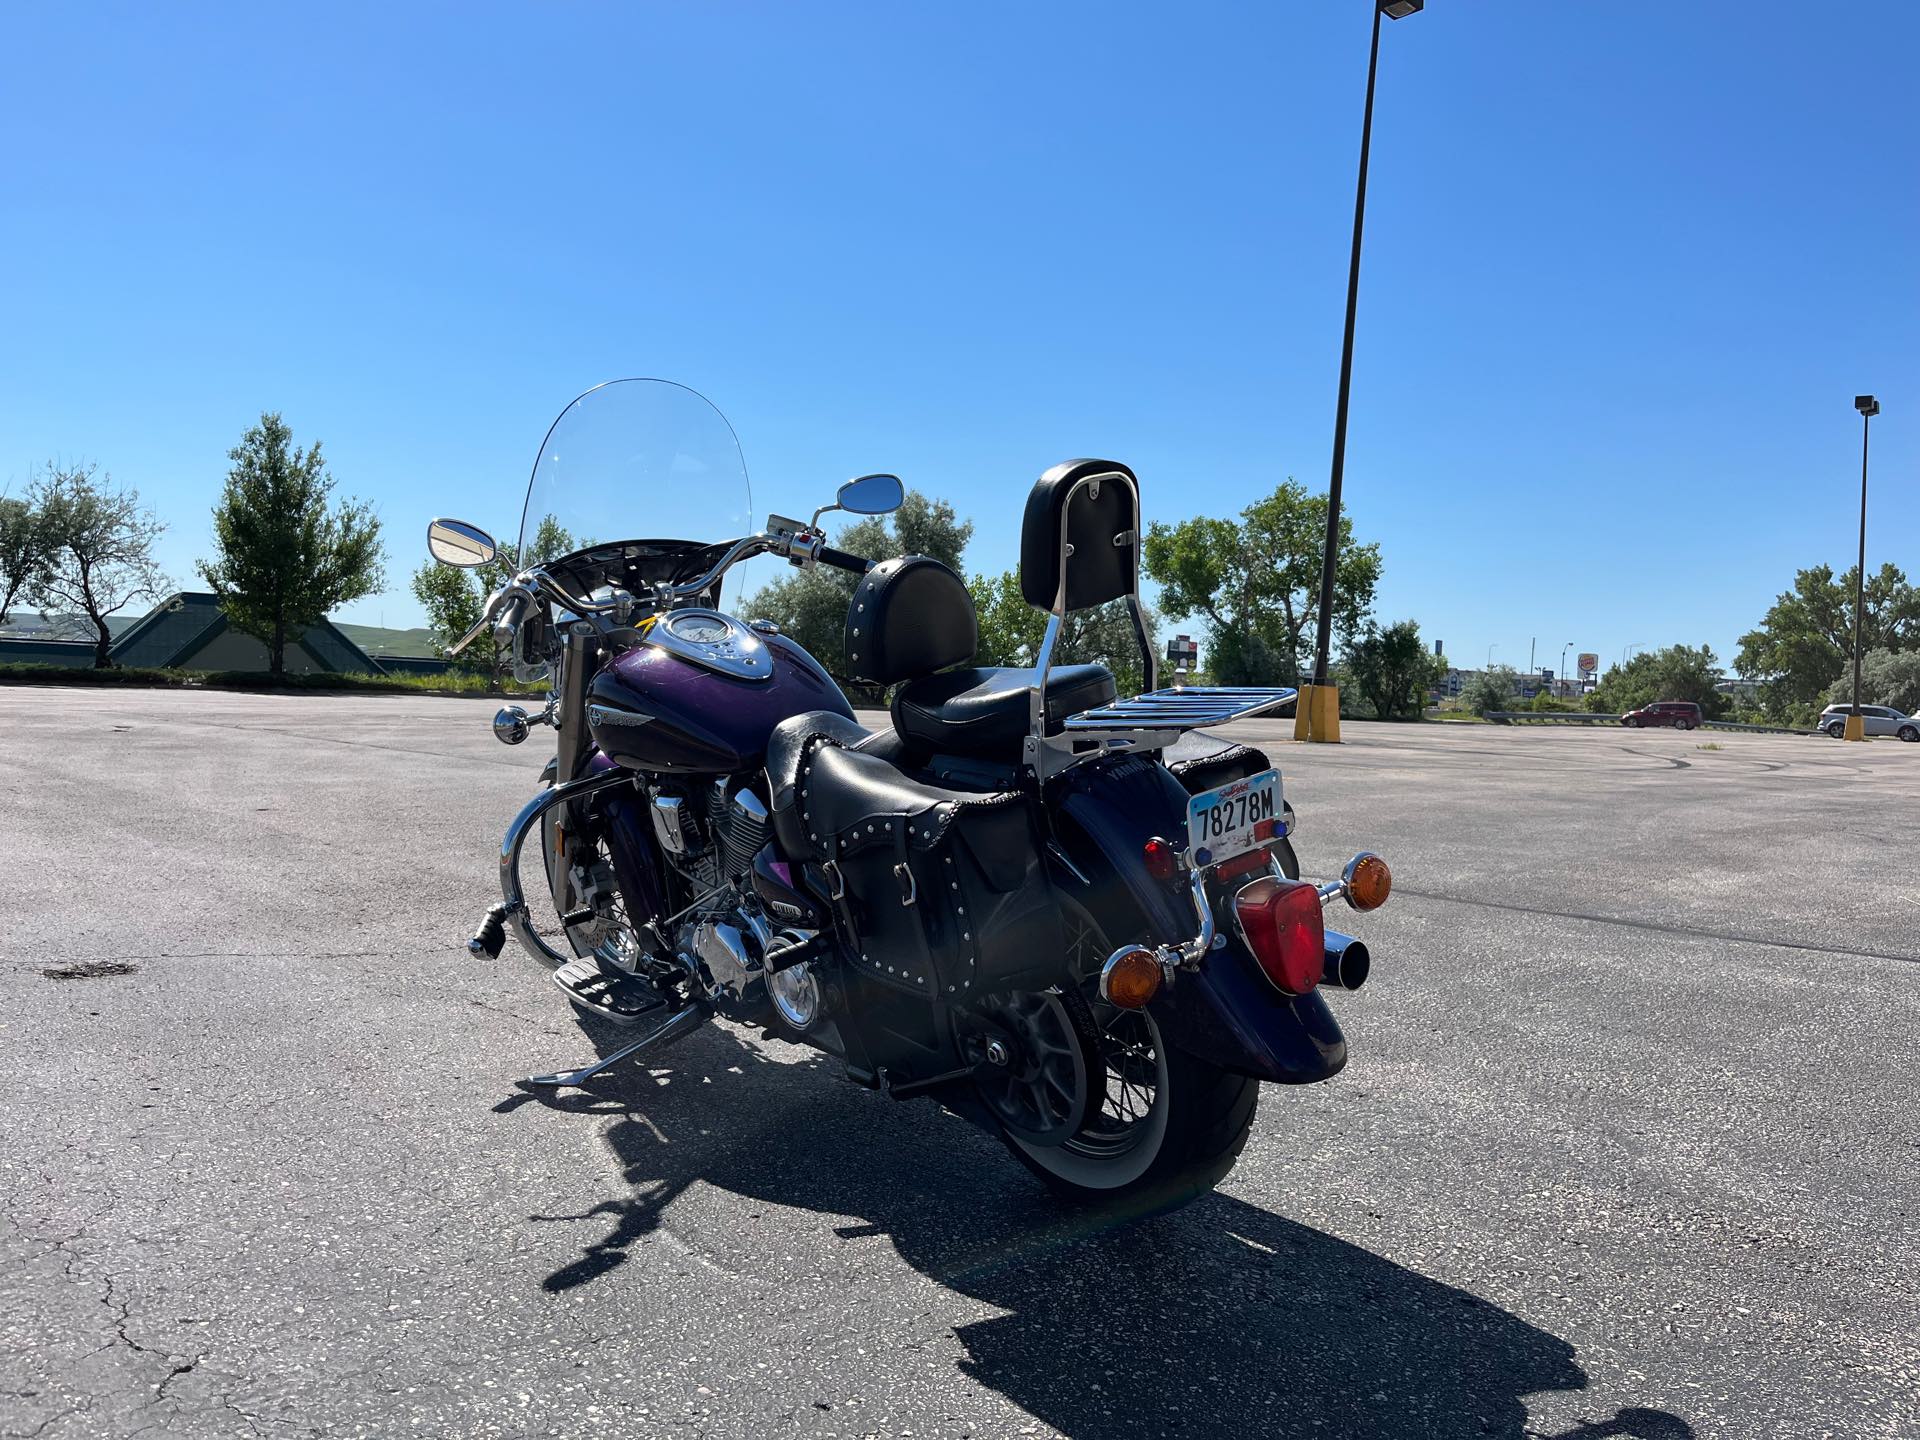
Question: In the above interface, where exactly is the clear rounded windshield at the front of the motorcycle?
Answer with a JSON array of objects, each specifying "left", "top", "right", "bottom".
[{"left": 518, "top": 380, "right": 756, "bottom": 602}]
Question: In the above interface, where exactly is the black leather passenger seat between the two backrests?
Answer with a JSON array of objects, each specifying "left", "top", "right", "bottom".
[{"left": 893, "top": 664, "right": 1116, "bottom": 760}]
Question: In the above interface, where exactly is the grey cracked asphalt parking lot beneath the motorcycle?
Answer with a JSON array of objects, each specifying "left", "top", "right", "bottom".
[{"left": 0, "top": 689, "right": 1920, "bottom": 1440}]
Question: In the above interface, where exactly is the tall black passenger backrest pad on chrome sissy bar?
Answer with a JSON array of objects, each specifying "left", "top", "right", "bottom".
[{"left": 1020, "top": 461, "right": 1140, "bottom": 611}]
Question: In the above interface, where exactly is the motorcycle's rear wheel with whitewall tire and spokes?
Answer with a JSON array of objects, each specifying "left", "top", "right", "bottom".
[{"left": 981, "top": 906, "right": 1260, "bottom": 1212}]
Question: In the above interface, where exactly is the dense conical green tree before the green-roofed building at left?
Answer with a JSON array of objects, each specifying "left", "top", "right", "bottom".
[{"left": 200, "top": 413, "right": 386, "bottom": 678}]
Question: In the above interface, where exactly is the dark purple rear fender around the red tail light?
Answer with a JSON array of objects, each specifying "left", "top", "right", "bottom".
[{"left": 1048, "top": 756, "right": 1346, "bottom": 1085}]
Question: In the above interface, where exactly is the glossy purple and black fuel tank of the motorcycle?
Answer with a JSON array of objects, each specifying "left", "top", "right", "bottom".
[{"left": 588, "top": 636, "right": 852, "bottom": 774}]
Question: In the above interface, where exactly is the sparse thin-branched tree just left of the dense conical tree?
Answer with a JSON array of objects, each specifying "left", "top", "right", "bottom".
[{"left": 31, "top": 465, "right": 167, "bottom": 670}]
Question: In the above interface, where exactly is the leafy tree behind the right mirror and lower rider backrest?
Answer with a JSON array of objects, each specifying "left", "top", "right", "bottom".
[{"left": 741, "top": 490, "right": 973, "bottom": 699}]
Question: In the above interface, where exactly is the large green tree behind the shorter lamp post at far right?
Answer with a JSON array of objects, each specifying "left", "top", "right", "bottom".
[{"left": 1734, "top": 564, "right": 1920, "bottom": 714}]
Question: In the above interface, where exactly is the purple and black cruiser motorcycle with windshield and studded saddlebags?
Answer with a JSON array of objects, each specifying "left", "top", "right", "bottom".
[{"left": 428, "top": 380, "right": 1392, "bottom": 1208}]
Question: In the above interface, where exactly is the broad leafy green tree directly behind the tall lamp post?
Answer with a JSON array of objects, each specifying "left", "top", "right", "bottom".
[{"left": 1144, "top": 480, "right": 1380, "bottom": 685}]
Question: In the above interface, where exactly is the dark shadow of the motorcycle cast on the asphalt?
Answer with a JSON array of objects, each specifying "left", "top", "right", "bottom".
[{"left": 501, "top": 1027, "right": 1693, "bottom": 1440}]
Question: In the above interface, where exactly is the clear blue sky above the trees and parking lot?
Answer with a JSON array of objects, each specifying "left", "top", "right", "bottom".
[{"left": 0, "top": 0, "right": 1920, "bottom": 664}]
